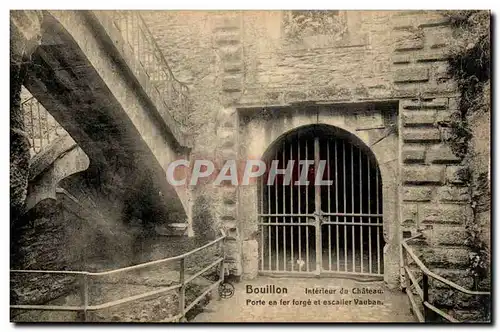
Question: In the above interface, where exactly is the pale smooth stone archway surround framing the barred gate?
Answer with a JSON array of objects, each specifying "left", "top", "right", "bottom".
[{"left": 238, "top": 105, "right": 401, "bottom": 287}]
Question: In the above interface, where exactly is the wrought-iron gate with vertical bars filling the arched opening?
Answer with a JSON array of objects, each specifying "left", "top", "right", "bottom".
[{"left": 257, "top": 134, "right": 383, "bottom": 276}]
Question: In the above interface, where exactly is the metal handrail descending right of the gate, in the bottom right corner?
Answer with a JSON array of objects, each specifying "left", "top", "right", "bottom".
[{"left": 401, "top": 233, "right": 491, "bottom": 323}]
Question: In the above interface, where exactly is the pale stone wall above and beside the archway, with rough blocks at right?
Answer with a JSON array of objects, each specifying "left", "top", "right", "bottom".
[{"left": 139, "top": 11, "right": 489, "bottom": 314}]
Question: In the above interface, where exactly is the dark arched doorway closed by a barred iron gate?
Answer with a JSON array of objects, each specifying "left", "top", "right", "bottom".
[{"left": 259, "top": 125, "right": 384, "bottom": 277}]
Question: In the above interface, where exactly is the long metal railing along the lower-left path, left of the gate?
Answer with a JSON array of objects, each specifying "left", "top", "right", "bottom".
[{"left": 10, "top": 230, "right": 226, "bottom": 322}]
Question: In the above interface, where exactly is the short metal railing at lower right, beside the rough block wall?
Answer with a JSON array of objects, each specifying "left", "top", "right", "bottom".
[{"left": 402, "top": 234, "right": 491, "bottom": 323}]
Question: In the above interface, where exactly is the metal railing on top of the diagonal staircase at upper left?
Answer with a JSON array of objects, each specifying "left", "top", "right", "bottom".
[{"left": 110, "top": 11, "right": 190, "bottom": 126}]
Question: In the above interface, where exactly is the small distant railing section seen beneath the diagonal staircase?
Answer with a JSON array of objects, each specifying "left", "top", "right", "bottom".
[{"left": 21, "top": 97, "right": 66, "bottom": 157}]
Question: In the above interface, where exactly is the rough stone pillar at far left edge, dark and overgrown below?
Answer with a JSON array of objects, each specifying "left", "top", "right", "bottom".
[{"left": 10, "top": 10, "right": 42, "bottom": 222}]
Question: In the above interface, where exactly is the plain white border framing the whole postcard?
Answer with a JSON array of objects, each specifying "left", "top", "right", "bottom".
[{"left": 0, "top": 0, "right": 500, "bottom": 332}]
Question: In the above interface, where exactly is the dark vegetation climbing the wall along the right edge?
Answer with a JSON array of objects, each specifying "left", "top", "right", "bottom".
[{"left": 445, "top": 10, "right": 491, "bottom": 288}]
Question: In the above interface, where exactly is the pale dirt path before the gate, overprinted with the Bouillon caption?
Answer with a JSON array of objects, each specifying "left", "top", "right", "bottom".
[{"left": 192, "top": 277, "right": 416, "bottom": 323}]
